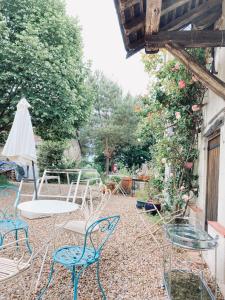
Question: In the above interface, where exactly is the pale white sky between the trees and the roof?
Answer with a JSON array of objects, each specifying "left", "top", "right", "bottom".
[{"left": 66, "top": 0, "right": 148, "bottom": 95}]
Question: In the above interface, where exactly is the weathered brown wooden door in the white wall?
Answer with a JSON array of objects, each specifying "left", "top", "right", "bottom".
[{"left": 206, "top": 134, "right": 220, "bottom": 226}]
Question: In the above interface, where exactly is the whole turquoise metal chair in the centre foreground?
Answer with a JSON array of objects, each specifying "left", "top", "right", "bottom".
[{"left": 37, "top": 216, "right": 120, "bottom": 300}]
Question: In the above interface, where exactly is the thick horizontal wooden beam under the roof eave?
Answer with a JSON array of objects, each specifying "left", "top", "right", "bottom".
[{"left": 145, "top": 30, "right": 225, "bottom": 51}]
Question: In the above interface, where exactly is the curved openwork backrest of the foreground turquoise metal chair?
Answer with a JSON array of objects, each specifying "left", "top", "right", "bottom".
[{"left": 83, "top": 216, "right": 120, "bottom": 256}]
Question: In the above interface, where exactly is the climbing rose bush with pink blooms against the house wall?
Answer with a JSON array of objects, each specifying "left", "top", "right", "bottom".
[{"left": 142, "top": 49, "right": 205, "bottom": 209}]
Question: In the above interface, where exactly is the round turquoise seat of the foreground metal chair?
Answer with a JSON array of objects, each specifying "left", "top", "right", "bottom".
[{"left": 53, "top": 246, "right": 99, "bottom": 267}]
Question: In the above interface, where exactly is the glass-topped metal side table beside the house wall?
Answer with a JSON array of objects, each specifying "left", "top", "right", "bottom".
[{"left": 163, "top": 219, "right": 218, "bottom": 300}]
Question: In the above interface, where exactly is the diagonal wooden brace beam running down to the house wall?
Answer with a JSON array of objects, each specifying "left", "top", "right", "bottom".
[{"left": 165, "top": 43, "right": 225, "bottom": 101}]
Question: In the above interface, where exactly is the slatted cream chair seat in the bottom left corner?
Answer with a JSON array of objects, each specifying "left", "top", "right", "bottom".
[{"left": 0, "top": 257, "right": 30, "bottom": 282}]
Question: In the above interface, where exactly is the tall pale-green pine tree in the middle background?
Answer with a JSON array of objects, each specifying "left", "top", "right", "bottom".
[{"left": 81, "top": 72, "right": 142, "bottom": 173}]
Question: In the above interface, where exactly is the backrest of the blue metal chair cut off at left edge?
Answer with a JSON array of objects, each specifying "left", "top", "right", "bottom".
[{"left": 0, "top": 184, "right": 20, "bottom": 219}]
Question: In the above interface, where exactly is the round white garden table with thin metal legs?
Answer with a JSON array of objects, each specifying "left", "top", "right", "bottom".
[{"left": 17, "top": 200, "right": 80, "bottom": 289}]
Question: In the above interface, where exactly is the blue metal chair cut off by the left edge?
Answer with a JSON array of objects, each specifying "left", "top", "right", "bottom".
[{"left": 0, "top": 184, "right": 32, "bottom": 253}]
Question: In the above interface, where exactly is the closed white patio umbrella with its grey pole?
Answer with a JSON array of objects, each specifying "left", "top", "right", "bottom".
[{"left": 2, "top": 98, "right": 37, "bottom": 198}]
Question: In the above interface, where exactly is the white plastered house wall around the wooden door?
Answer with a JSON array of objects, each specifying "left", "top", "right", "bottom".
[{"left": 194, "top": 1, "right": 225, "bottom": 296}]
